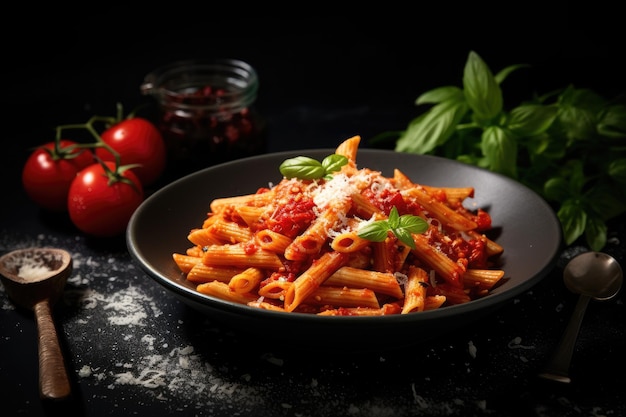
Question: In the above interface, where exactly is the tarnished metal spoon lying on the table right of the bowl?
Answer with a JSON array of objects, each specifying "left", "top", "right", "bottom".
[{"left": 539, "top": 252, "right": 623, "bottom": 383}]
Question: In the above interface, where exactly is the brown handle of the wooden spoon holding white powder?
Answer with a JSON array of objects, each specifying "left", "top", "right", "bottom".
[{"left": 33, "top": 300, "right": 70, "bottom": 400}]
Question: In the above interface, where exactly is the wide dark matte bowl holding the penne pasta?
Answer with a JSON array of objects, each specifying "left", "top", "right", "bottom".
[{"left": 126, "top": 149, "right": 562, "bottom": 350}]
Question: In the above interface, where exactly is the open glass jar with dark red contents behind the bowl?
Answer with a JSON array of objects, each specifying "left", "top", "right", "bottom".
[{"left": 140, "top": 59, "right": 267, "bottom": 176}]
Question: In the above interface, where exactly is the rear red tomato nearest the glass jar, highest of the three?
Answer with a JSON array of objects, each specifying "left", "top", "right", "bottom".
[{"left": 96, "top": 117, "right": 167, "bottom": 185}]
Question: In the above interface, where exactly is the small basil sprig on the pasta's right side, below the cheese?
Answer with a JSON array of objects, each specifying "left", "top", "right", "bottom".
[{"left": 357, "top": 206, "right": 428, "bottom": 249}]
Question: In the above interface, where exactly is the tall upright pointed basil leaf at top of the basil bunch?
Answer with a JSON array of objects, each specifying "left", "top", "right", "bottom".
[{"left": 463, "top": 51, "right": 503, "bottom": 120}]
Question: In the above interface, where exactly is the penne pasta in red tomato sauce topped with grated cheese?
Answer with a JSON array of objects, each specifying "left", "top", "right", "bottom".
[{"left": 173, "top": 136, "right": 504, "bottom": 316}]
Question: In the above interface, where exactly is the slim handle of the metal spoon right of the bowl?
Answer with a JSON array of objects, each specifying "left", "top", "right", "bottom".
[{"left": 539, "top": 295, "right": 591, "bottom": 383}]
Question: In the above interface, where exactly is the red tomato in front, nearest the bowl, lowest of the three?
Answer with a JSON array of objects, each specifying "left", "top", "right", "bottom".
[{"left": 67, "top": 162, "right": 143, "bottom": 237}]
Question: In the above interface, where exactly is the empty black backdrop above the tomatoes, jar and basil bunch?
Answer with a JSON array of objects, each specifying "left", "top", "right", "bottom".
[{"left": 2, "top": 8, "right": 626, "bottom": 162}]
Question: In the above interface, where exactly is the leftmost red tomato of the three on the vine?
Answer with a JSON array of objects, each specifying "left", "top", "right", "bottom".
[{"left": 22, "top": 140, "right": 94, "bottom": 211}]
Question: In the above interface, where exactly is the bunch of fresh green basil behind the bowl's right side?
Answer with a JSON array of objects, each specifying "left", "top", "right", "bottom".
[{"left": 372, "top": 51, "right": 626, "bottom": 250}]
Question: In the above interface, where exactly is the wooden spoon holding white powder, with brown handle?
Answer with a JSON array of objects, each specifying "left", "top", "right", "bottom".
[{"left": 0, "top": 248, "right": 72, "bottom": 400}]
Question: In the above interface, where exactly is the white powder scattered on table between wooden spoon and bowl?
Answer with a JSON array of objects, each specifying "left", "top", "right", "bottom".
[{"left": 66, "top": 260, "right": 263, "bottom": 407}]
